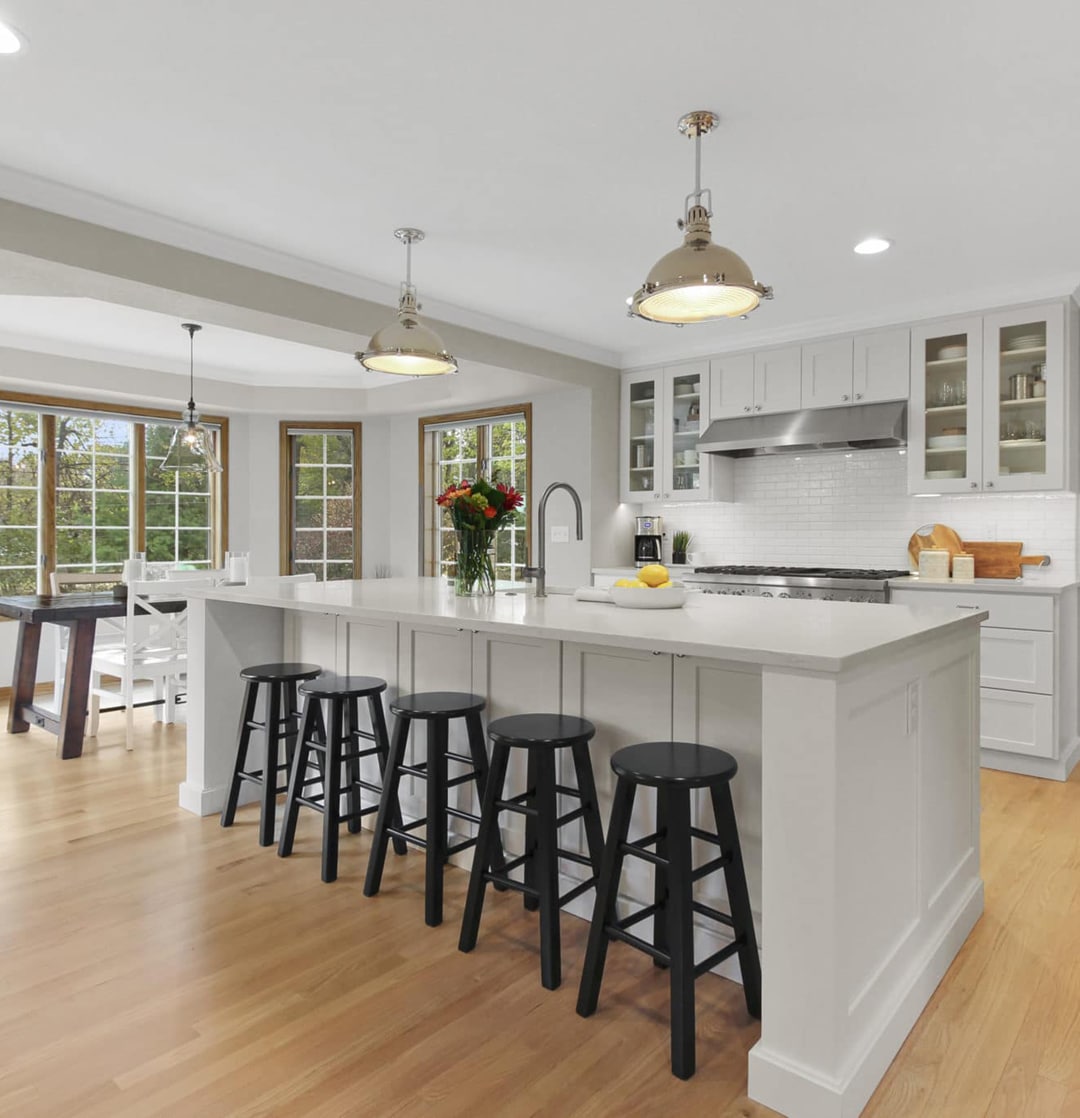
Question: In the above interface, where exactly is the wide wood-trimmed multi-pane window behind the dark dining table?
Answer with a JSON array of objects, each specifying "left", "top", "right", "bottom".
[{"left": 0, "top": 394, "right": 228, "bottom": 594}]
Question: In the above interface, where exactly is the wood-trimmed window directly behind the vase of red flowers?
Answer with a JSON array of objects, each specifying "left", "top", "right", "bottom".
[{"left": 419, "top": 404, "right": 532, "bottom": 584}]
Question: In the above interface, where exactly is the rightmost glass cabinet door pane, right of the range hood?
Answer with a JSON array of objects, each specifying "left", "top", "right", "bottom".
[{"left": 995, "top": 322, "right": 1046, "bottom": 476}]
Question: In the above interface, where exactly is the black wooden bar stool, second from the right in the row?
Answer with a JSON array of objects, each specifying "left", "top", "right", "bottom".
[{"left": 457, "top": 714, "right": 604, "bottom": 989}]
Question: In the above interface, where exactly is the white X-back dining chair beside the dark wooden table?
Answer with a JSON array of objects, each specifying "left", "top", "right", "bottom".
[{"left": 91, "top": 578, "right": 214, "bottom": 750}]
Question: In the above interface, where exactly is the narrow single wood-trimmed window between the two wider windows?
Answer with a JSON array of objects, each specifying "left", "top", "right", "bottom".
[{"left": 280, "top": 423, "right": 361, "bottom": 582}]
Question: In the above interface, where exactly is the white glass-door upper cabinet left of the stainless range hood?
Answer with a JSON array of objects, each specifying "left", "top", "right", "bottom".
[{"left": 619, "top": 361, "right": 732, "bottom": 503}]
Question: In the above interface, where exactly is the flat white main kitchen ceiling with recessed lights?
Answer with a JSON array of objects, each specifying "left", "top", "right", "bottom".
[{"left": 0, "top": 0, "right": 1080, "bottom": 363}]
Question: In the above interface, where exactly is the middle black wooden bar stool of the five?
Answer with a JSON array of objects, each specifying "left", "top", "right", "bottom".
[{"left": 363, "top": 691, "right": 502, "bottom": 928}]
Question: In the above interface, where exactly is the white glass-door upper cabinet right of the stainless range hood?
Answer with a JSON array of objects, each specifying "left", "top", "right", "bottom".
[{"left": 908, "top": 304, "right": 1068, "bottom": 493}]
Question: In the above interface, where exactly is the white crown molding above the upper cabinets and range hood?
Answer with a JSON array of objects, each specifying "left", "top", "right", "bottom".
[{"left": 620, "top": 273, "right": 1080, "bottom": 372}]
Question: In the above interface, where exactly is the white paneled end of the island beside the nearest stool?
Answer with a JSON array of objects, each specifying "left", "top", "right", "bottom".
[{"left": 749, "top": 626, "right": 982, "bottom": 1118}]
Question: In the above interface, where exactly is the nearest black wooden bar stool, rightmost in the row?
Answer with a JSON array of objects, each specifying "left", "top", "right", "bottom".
[{"left": 578, "top": 741, "right": 761, "bottom": 1079}]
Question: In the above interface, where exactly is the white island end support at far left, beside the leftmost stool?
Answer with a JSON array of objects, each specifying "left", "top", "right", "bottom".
[{"left": 180, "top": 597, "right": 284, "bottom": 815}]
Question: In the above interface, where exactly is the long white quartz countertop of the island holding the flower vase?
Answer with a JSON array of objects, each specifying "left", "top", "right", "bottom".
[{"left": 186, "top": 578, "right": 988, "bottom": 672}]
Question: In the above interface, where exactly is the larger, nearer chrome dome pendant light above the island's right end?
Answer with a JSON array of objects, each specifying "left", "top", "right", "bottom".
[{"left": 626, "top": 110, "right": 773, "bottom": 325}]
